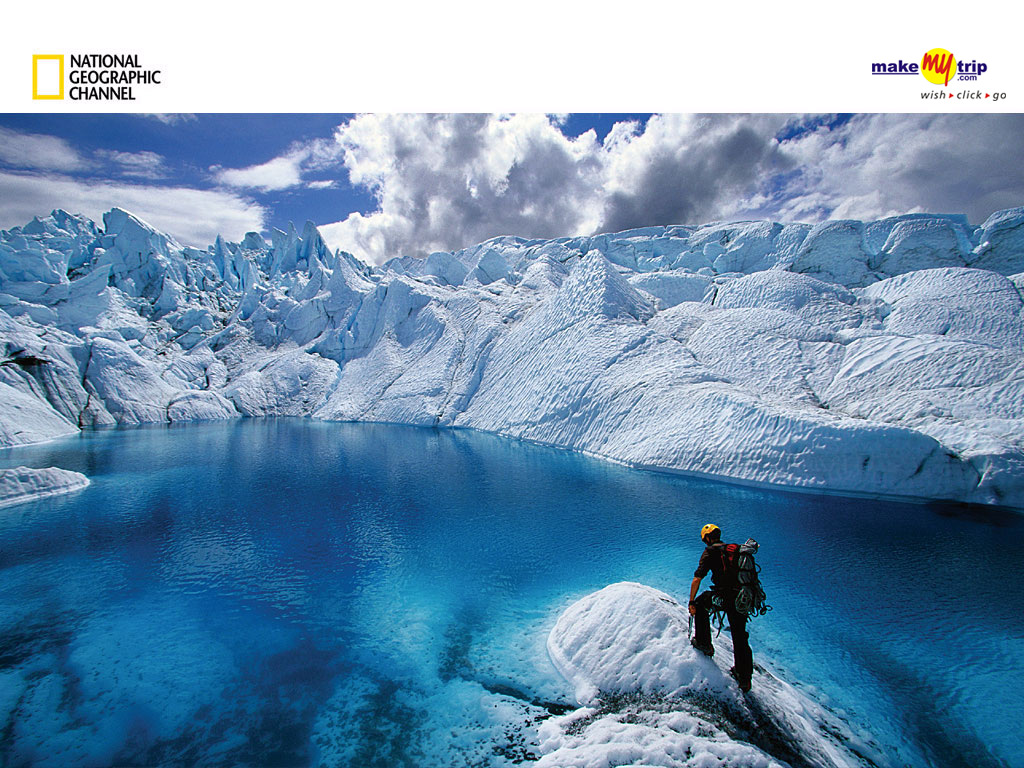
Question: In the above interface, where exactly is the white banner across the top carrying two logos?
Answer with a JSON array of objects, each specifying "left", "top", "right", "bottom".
[{"left": 0, "top": 0, "right": 1024, "bottom": 113}]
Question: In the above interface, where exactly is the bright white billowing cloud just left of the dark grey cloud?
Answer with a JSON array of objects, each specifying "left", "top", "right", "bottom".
[{"left": 322, "top": 115, "right": 602, "bottom": 261}]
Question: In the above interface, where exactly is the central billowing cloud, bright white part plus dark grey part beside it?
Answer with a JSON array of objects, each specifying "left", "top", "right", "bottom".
[{"left": 322, "top": 115, "right": 793, "bottom": 261}]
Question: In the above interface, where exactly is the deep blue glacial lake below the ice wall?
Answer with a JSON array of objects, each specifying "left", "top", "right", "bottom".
[{"left": 0, "top": 419, "right": 1024, "bottom": 768}]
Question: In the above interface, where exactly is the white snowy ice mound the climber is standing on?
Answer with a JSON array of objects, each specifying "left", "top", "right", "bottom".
[{"left": 538, "top": 583, "right": 885, "bottom": 768}]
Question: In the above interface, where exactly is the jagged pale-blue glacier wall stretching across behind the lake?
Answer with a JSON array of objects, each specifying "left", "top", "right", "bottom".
[{"left": 0, "top": 208, "right": 1024, "bottom": 509}]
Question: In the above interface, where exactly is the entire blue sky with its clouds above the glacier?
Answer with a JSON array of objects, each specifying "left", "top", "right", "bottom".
[{"left": 0, "top": 115, "right": 1024, "bottom": 262}]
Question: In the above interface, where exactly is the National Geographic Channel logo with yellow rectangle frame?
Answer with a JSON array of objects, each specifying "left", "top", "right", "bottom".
[{"left": 32, "top": 53, "right": 163, "bottom": 101}]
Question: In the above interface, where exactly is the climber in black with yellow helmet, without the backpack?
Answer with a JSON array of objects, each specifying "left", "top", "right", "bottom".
[{"left": 689, "top": 523, "right": 754, "bottom": 692}]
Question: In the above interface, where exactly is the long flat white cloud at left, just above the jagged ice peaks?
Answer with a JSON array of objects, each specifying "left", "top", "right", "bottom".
[{"left": 0, "top": 171, "right": 266, "bottom": 248}]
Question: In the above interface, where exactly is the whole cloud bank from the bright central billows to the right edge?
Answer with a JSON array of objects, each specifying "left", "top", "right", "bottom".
[{"left": 309, "top": 115, "right": 1024, "bottom": 262}]
